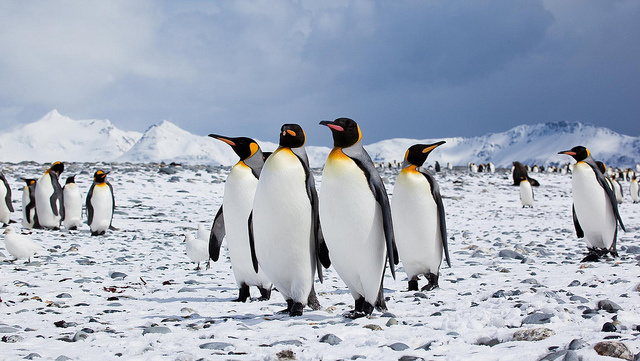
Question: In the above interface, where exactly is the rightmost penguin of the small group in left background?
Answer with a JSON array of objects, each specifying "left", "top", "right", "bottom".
[{"left": 86, "top": 170, "right": 116, "bottom": 236}]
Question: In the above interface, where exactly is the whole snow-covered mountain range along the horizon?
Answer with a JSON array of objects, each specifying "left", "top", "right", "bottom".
[{"left": 0, "top": 110, "right": 640, "bottom": 167}]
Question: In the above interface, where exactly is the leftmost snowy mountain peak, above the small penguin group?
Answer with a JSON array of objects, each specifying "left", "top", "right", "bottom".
[{"left": 0, "top": 110, "right": 142, "bottom": 163}]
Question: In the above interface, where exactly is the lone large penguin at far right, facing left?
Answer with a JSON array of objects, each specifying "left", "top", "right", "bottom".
[{"left": 558, "top": 146, "right": 625, "bottom": 262}]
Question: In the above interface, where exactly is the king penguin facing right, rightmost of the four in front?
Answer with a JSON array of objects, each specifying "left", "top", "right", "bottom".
[{"left": 391, "top": 141, "right": 451, "bottom": 291}]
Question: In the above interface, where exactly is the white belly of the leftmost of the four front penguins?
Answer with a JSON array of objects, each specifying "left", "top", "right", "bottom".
[{"left": 222, "top": 163, "right": 271, "bottom": 288}]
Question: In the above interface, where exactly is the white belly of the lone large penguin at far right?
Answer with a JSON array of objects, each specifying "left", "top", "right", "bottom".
[{"left": 572, "top": 162, "right": 617, "bottom": 249}]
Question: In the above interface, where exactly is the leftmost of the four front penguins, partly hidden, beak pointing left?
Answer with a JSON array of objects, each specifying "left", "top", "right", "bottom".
[{"left": 209, "top": 134, "right": 272, "bottom": 302}]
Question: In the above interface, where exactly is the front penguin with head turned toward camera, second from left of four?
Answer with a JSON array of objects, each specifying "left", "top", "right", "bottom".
[{"left": 249, "top": 124, "right": 331, "bottom": 316}]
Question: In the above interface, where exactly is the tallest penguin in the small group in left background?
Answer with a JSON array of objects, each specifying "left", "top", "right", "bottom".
[{"left": 36, "top": 162, "right": 64, "bottom": 229}]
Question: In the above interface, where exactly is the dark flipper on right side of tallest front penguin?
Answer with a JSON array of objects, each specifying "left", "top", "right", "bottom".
[{"left": 342, "top": 146, "right": 399, "bottom": 279}]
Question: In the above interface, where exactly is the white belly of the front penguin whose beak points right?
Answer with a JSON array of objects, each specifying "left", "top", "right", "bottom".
[{"left": 391, "top": 171, "right": 443, "bottom": 279}]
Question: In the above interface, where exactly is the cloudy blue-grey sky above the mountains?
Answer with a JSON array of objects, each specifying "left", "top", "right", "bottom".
[{"left": 0, "top": 0, "right": 640, "bottom": 145}]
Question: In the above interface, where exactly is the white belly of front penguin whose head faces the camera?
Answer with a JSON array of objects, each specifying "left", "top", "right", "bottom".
[{"left": 253, "top": 148, "right": 315, "bottom": 305}]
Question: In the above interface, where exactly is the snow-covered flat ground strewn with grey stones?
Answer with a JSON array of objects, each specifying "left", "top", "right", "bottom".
[{"left": 0, "top": 163, "right": 640, "bottom": 361}]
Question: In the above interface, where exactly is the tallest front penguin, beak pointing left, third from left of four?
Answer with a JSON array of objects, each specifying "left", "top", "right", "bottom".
[{"left": 320, "top": 118, "right": 398, "bottom": 318}]
